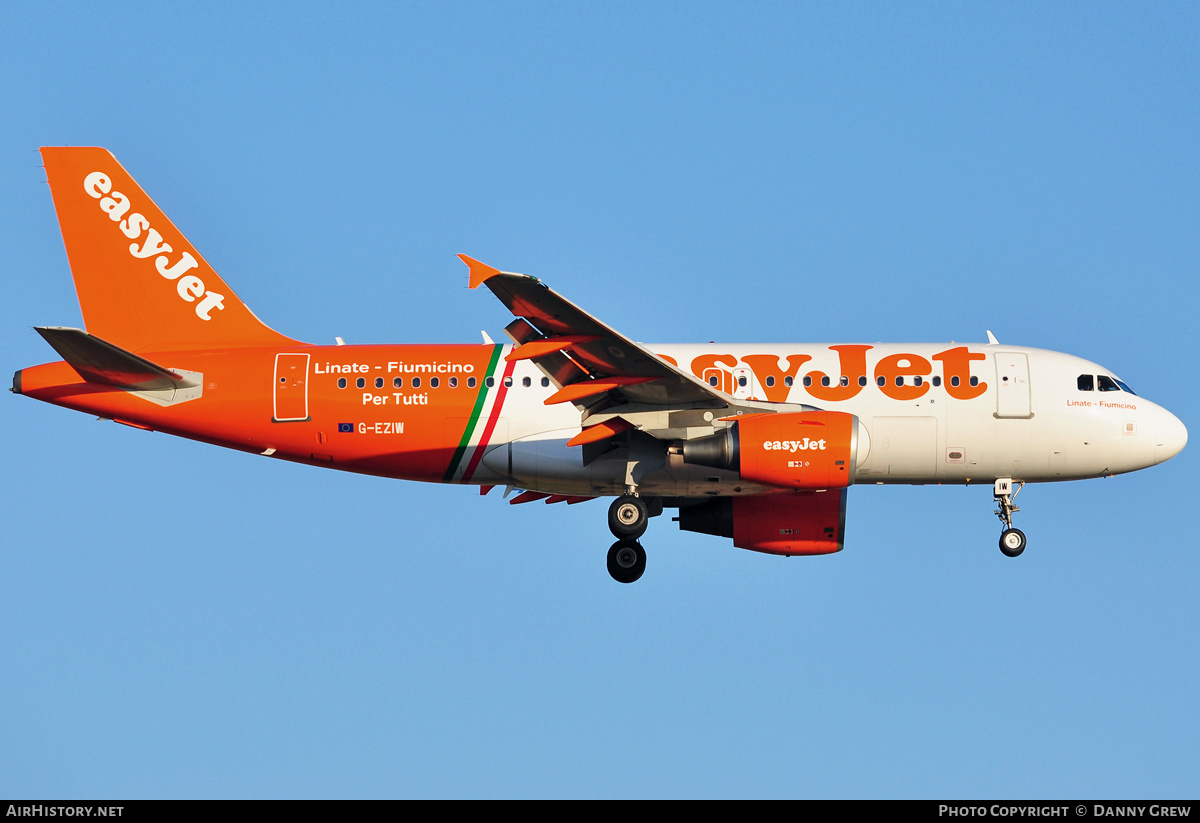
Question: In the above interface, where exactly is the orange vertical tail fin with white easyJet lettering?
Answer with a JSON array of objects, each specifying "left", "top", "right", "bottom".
[{"left": 42, "top": 148, "right": 296, "bottom": 352}]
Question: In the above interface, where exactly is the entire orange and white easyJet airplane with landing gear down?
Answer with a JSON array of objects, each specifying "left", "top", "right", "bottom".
[{"left": 12, "top": 148, "right": 1187, "bottom": 583}]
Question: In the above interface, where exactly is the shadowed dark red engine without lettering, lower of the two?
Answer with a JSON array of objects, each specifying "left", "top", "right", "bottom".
[{"left": 679, "top": 489, "right": 846, "bottom": 555}]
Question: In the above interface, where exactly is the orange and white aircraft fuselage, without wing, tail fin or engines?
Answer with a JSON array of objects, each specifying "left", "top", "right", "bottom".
[{"left": 20, "top": 343, "right": 1186, "bottom": 497}]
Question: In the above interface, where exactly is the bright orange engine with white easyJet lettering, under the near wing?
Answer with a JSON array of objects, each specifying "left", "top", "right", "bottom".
[{"left": 683, "top": 412, "right": 858, "bottom": 489}]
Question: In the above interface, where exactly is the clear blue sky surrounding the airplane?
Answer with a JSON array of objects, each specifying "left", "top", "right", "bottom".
[{"left": 0, "top": 2, "right": 1200, "bottom": 798}]
